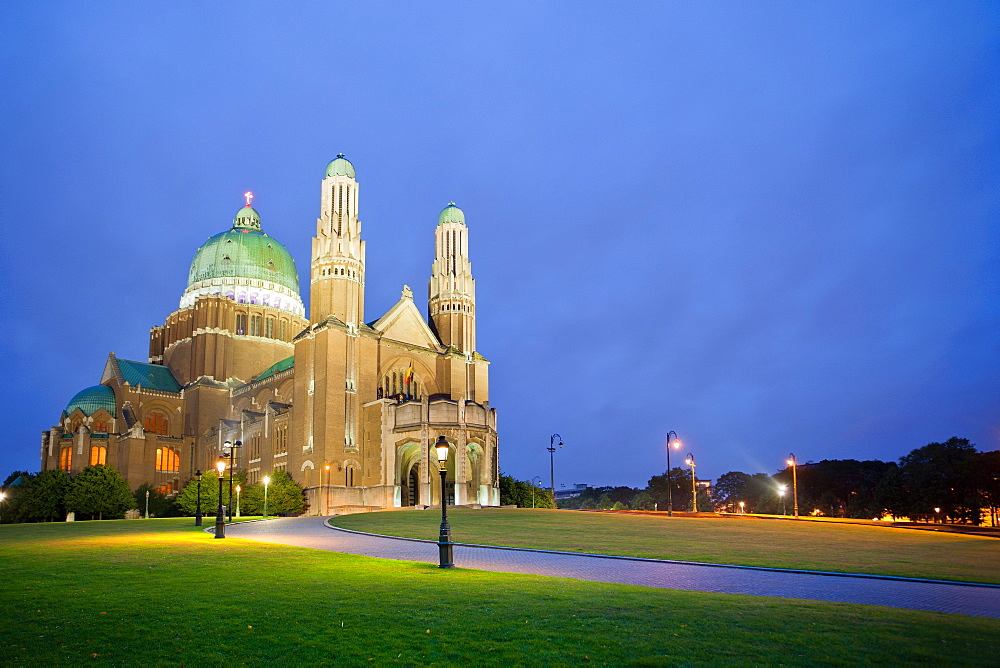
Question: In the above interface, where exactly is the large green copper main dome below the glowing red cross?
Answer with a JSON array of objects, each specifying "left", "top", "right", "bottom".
[{"left": 188, "top": 227, "right": 299, "bottom": 294}]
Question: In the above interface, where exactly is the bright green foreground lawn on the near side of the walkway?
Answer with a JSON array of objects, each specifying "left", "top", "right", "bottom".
[{"left": 0, "top": 519, "right": 1000, "bottom": 666}]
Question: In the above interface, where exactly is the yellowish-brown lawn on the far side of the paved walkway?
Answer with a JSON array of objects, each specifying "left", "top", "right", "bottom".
[{"left": 334, "top": 508, "right": 1000, "bottom": 583}]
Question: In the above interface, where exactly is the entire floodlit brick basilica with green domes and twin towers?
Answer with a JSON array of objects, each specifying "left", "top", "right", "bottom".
[{"left": 41, "top": 154, "right": 499, "bottom": 515}]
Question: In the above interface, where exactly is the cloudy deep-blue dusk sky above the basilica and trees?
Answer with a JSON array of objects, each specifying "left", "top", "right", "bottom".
[{"left": 0, "top": 1, "right": 1000, "bottom": 486}]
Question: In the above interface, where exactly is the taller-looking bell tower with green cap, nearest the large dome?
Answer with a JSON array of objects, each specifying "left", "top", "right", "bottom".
[{"left": 309, "top": 153, "right": 365, "bottom": 328}]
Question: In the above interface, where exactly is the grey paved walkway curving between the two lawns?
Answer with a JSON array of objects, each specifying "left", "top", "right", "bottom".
[{"left": 226, "top": 517, "right": 1000, "bottom": 619}]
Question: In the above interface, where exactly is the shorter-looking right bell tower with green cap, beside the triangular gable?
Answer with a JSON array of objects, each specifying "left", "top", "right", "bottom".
[{"left": 427, "top": 202, "right": 476, "bottom": 358}]
